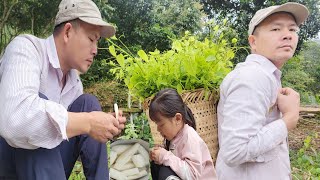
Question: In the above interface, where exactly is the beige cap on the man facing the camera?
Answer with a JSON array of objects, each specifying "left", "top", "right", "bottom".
[{"left": 248, "top": 2, "right": 309, "bottom": 35}]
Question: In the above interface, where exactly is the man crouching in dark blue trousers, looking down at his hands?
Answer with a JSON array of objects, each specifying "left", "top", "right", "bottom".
[{"left": 0, "top": 0, "right": 126, "bottom": 180}]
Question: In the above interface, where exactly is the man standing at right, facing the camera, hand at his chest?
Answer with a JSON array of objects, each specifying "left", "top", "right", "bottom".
[{"left": 216, "top": 3, "right": 309, "bottom": 180}]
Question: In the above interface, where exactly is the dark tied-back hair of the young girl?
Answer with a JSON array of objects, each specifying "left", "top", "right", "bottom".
[{"left": 149, "top": 88, "right": 196, "bottom": 130}]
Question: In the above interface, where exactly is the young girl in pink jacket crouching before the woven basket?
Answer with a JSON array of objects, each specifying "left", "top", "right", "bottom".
[{"left": 149, "top": 89, "right": 217, "bottom": 180}]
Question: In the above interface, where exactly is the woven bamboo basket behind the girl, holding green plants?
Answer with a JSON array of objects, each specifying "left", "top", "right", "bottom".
[{"left": 143, "top": 89, "right": 219, "bottom": 163}]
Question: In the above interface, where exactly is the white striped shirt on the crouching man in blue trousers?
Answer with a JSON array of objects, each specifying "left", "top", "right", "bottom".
[{"left": 0, "top": 35, "right": 83, "bottom": 149}]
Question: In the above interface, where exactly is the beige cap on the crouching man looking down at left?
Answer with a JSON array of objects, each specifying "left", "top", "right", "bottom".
[{"left": 54, "top": 0, "right": 116, "bottom": 38}]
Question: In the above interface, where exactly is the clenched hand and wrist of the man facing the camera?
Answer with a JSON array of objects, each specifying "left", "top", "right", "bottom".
[{"left": 277, "top": 88, "right": 300, "bottom": 130}]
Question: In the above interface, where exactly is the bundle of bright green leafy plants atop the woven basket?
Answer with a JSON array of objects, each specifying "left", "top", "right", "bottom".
[{"left": 109, "top": 23, "right": 237, "bottom": 99}]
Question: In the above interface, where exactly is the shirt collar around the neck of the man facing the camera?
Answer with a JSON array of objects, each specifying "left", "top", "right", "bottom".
[{"left": 246, "top": 54, "right": 282, "bottom": 79}]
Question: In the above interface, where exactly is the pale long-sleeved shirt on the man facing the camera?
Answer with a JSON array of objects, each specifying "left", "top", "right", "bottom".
[{"left": 216, "top": 54, "right": 290, "bottom": 180}]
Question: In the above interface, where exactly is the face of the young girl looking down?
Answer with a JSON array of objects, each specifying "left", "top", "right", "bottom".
[{"left": 156, "top": 113, "right": 184, "bottom": 141}]
